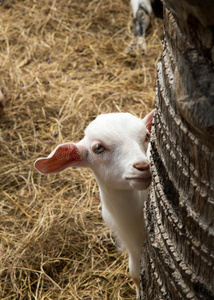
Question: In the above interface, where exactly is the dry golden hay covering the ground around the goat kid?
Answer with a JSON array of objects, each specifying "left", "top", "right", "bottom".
[{"left": 0, "top": 0, "right": 162, "bottom": 299}]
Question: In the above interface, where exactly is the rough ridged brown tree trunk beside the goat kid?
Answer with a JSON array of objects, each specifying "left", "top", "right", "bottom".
[{"left": 140, "top": 0, "right": 214, "bottom": 300}]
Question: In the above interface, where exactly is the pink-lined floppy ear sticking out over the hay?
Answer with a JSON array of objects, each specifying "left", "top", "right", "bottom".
[{"left": 34, "top": 143, "right": 87, "bottom": 174}]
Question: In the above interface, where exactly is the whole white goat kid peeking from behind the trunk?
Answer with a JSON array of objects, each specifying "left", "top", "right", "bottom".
[{"left": 35, "top": 110, "right": 154, "bottom": 295}]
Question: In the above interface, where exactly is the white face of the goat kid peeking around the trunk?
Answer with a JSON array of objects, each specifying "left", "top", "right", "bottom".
[{"left": 84, "top": 113, "right": 151, "bottom": 190}]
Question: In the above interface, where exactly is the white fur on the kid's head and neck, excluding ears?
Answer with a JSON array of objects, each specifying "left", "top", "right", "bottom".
[{"left": 85, "top": 114, "right": 148, "bottom": 296}]
